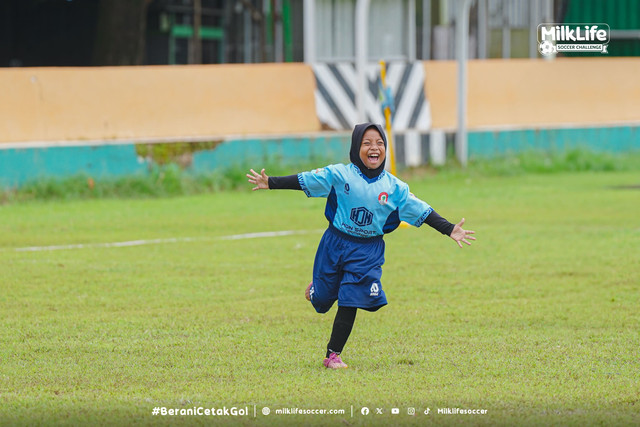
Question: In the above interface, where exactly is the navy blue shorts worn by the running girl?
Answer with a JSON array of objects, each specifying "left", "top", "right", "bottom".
[{"left": 310, "top": 226, "right": 387, "bottom": 313}]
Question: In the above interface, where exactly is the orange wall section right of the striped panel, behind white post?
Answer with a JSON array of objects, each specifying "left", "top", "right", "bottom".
[{"left": 424, "top": 58, "right": 640, "bottom": 129}]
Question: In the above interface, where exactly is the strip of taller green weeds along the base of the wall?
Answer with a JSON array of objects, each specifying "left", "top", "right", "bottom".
[{"left": 0, "top": 149, "right": 640, "bottom": 203}]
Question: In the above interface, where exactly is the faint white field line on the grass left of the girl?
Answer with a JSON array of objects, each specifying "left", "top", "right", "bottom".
[{"left": 7, "top": 230, "right": 322, "bottom": 252}]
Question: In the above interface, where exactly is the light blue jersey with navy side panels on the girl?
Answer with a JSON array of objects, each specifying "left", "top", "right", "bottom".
[{"left": 298, "top": 163, "right": 433, "bottom": 238}]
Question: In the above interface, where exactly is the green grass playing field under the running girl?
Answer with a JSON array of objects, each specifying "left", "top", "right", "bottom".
[{"left": 0, "top": 172, "right": 640, "bottom": 426}]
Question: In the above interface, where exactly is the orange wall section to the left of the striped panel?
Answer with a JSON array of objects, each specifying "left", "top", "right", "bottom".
[{"left": 0, "top": 64, "right": 320, "bottom": 142}]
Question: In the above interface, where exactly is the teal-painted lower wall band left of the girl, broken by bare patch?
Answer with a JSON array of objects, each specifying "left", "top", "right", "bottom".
[{"left": 0, "top": 134, "right": 351, "bottom": 188}]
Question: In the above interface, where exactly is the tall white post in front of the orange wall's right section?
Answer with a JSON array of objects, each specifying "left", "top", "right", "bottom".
[{"left": 456, "top": 0, "right": 471, "bottom": 166}]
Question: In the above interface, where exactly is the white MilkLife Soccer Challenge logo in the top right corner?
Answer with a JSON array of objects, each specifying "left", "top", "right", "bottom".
[{"left": 538, "top": 24, "right": 611, "bottom": 56}]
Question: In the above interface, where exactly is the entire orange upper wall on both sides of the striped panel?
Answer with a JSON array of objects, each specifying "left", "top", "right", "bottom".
[{"left": 0, "top": 58, "right": 640, "bottom": 143}]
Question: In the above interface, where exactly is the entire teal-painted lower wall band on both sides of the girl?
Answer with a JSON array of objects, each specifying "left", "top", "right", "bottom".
[{"left": 0, "top": 126, "right": 640, "bottom": 188}]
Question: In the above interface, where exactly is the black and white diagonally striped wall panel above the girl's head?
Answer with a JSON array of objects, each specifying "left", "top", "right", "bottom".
[{"left": 313, "top": 62, "right": 431, "bottom": 132}]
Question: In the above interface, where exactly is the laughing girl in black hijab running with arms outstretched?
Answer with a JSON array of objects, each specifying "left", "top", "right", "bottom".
[{"left": 247, "top": 123, "right": 475, "bottom": 369}]
